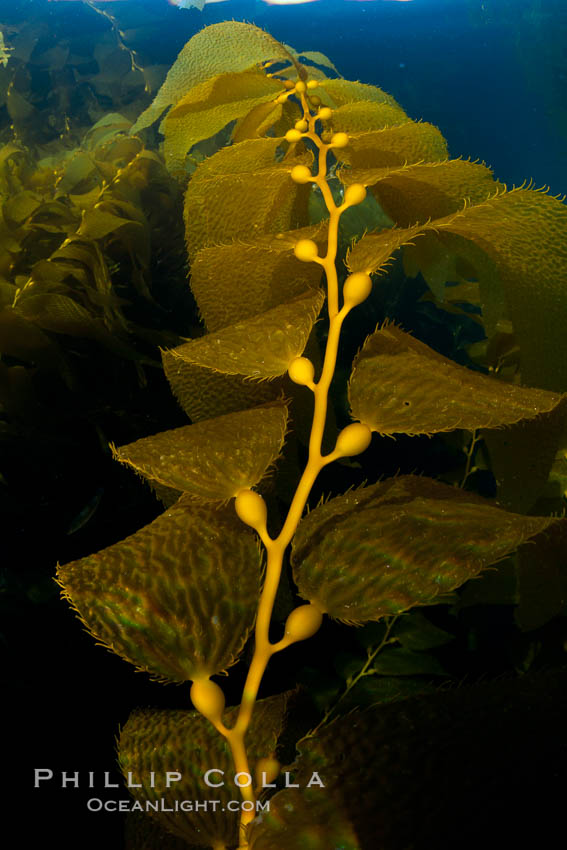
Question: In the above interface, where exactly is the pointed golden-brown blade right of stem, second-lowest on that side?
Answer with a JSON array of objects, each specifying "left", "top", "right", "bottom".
[{"left": 349, "top": 325, "right": 562, "bottom": 436}]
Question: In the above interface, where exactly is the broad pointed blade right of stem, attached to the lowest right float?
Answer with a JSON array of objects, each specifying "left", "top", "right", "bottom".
[{"left": 292, "top": 476, "right": 565, "bottom": 623}]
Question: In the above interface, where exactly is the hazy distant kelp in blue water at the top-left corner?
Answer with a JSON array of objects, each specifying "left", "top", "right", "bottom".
[{"left": 0, "top": 0, "right": 151, "bottom": 151}]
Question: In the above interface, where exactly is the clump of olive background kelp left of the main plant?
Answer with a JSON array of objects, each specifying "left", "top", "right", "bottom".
[{"left": 0, "top": 115, "right": 193, "bottom": 396}]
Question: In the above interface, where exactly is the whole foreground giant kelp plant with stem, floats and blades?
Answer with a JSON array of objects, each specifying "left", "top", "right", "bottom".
[{"left": 53, "top": 22, "right": 567, "bottom": 850}]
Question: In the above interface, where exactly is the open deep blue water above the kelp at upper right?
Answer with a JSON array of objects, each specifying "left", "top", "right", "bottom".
[{"left": 143, "top": 0, "right": 567, "bottom": 193}]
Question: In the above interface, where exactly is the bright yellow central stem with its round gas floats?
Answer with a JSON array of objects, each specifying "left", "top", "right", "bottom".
[{"left": 191, "top": 80, "right": 372, "bottom": 850}]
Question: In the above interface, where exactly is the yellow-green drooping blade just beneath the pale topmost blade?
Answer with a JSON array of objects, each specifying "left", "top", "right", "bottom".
[{"left": 162, "top": 71, "right": 283, "bottom": 175}]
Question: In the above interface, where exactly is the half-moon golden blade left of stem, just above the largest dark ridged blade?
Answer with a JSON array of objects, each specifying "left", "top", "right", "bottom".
[{"left": 114, "top": 403, "right": 287, "bottom": 502}]
